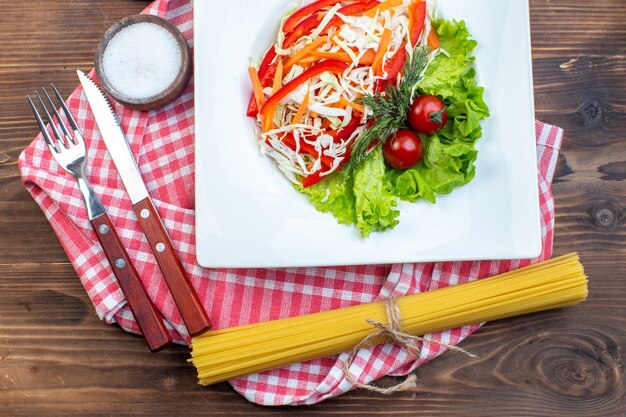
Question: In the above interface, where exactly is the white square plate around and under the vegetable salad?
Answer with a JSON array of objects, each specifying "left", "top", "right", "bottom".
[{"left": 194, "top": 0, "right": 541, "bottom": 268}]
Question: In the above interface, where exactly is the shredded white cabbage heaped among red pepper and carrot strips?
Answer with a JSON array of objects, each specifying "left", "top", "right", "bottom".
[{"left": 250, "top": 0, "right": 434, "bottom": 184}]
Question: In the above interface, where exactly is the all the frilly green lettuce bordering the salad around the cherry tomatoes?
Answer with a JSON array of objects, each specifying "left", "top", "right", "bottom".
[{"left": 296, "top": 19, "right": 489, "bottom": 237}]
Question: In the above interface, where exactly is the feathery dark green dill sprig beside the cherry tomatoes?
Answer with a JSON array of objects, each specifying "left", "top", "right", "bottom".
[{"left": 344, "top": 46, "right": 430, "bottom": 175}]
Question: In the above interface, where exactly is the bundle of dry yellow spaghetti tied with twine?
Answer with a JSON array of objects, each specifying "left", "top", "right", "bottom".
[{"left": 189, "top": 250, "right": 588, "bottom": 385}]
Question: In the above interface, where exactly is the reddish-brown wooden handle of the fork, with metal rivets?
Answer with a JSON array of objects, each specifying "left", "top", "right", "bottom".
[{"left": 91, "top": 214, "right": 172, "bottom": 352}]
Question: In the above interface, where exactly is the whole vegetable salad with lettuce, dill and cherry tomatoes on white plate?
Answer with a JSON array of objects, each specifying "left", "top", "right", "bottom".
[{"left": 247, "top": 0, "right": 489, "bottom": 236}]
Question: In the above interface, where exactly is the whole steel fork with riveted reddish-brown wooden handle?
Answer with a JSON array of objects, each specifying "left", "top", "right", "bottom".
[{"left": 28, "top": 84, "right": 172, "bottom": 352}]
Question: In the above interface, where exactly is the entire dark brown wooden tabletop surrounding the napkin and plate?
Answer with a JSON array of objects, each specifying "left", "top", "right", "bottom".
[{"left": 0, "top": 0, "right": 626, "bottom": 417}]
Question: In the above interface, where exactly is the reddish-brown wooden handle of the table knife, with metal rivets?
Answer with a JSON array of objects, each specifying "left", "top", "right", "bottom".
[{"left": 133, "top": 198, "right": 211, "bottom": 336}]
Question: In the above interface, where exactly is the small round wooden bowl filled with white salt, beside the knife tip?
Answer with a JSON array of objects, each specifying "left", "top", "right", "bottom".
[{"left": 96, "top": 15, "right": 191, "bottom": 110}]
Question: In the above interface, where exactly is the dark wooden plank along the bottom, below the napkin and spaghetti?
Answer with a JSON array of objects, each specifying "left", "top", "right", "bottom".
[{"left": 0, "top": 255, "right": 626, "bottom": 416}]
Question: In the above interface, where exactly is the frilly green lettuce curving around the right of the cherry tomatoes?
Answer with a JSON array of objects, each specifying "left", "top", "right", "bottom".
[{"left": 385, "top": 20, "right": 489, "bottom": 203}]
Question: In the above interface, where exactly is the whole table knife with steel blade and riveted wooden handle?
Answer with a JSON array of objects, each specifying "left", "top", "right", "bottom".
[{"left": 77, "top": 71, "right": 211, "bottom": 336}]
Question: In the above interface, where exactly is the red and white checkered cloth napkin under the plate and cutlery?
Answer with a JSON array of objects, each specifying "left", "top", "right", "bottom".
[{"left": 19, "top": 0, "right": 563, "bottom": 405}]
